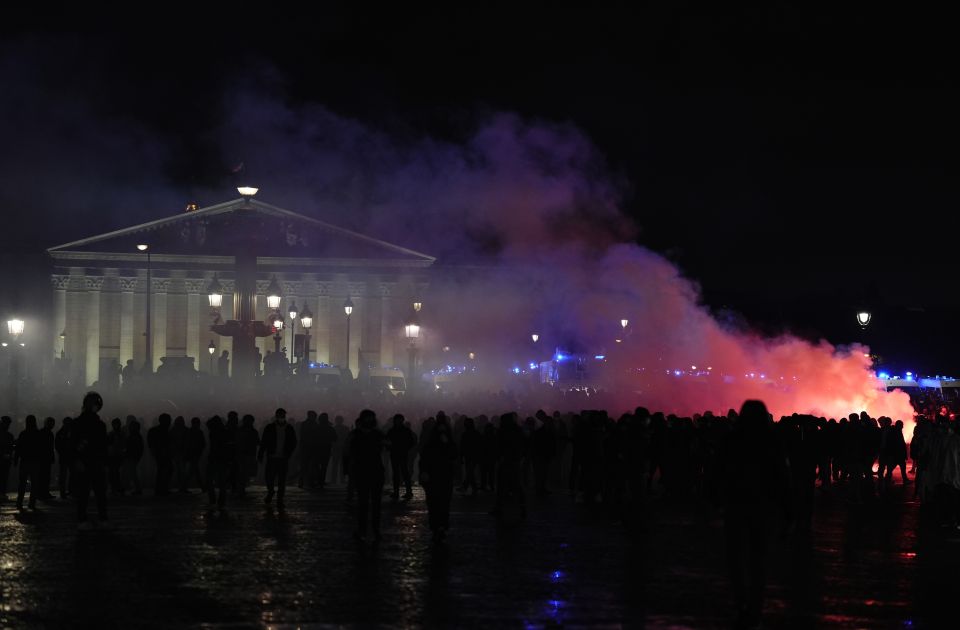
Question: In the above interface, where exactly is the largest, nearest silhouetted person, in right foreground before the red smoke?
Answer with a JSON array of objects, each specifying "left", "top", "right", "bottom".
[{"left": 722, "top": 400, "right": 789, "bottom": 627}]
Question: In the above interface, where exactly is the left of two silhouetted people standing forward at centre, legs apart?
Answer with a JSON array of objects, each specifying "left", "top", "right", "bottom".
[{"left": 350, "top": 409, "right": 384, "bottom": 541}]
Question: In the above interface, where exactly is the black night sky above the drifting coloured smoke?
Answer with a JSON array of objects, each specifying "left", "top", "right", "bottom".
[{"left": 0, "top": 3, "right": 960, "bottom": 372}]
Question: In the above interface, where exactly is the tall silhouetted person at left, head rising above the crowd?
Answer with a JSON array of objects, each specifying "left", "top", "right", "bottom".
[{"left": 70, "top": 392, "right": 109, "bottom": 530}]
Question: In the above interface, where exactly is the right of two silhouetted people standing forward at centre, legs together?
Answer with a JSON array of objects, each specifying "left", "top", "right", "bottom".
[{"left": 420, "top": 421, "right": 459, "bottom": 542}]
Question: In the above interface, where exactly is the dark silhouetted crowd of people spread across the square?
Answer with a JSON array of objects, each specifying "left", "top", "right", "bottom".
[{"left": 0, "top": 392, "right": 960, "bottom": 628}]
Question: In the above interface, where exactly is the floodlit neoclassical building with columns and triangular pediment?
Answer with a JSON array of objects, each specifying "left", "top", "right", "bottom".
[{"left": 48, "top": 196, "right": 434, "bottom": 384}]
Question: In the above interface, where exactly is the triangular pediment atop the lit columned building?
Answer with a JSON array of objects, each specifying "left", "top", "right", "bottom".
[{"left": 47, "top": 198, "right": 434, "bottom": 264}]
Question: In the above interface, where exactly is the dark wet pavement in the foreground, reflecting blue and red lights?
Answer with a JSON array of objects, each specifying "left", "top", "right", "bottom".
[{"left": 0, "top": 478, "right": 948, "bottom": 628}]
